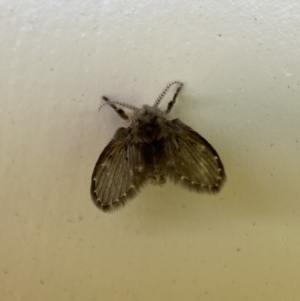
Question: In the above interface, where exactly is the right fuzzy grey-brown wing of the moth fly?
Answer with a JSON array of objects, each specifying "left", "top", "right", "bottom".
[{"left": 164, "top": 119, "right": 226, "bottom": 193}]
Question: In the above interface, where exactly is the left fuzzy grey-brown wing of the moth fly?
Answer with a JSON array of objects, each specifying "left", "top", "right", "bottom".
[{"left": 91, "top": 128, "right": 149, "bottom": 211}]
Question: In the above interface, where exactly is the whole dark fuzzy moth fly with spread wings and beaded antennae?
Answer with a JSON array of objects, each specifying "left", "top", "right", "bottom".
[{"left": 90, "top": 81, "right": 226, "bottom": 212}]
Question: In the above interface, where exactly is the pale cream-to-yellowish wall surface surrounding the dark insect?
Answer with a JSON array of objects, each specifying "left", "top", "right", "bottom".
[{"left": 0, "top": 0, "right": 300, "bottom": 301}]
